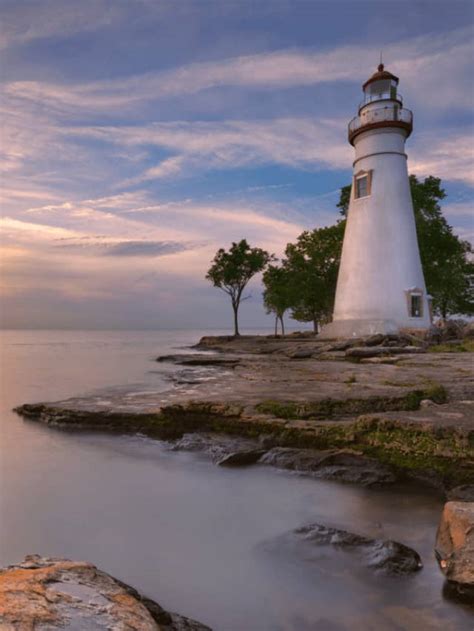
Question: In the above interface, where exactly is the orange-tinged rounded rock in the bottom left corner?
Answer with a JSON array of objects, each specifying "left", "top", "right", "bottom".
[{"left": 0, "top": 555, "right": 211, "bottom": 631}]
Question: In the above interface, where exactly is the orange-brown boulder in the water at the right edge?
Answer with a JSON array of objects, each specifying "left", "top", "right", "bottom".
[{"left": 435, "top": 502, "right": 474, "bottom": 603}]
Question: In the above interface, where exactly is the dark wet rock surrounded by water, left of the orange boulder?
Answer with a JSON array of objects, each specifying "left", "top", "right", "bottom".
[{"left": 294, "top": 524, "right": 423, "bottom": 575}]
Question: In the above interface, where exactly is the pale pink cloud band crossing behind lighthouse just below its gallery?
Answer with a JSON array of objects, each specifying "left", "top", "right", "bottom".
[{"left": 68, "top": 117, "right": 474, "bottom": 187}]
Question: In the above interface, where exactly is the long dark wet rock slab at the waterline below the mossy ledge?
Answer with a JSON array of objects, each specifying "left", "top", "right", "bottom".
[{"left": 260, "top": 447, "right": 397, "bottom": 486}]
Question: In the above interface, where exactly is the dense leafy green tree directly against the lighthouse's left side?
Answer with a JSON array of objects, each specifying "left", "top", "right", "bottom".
[{"left": 285, "top": 221, "right": 345, "bottom": 333}]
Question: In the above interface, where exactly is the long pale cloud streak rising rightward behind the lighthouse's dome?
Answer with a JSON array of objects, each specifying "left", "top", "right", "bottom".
[{"left": 5, "top": 27, "right": 472, "bottom": 114}]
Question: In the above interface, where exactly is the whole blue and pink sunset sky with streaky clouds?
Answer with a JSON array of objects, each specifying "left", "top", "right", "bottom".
[{"left": 0, "top": 0, "right": 474, "bottom": 332}]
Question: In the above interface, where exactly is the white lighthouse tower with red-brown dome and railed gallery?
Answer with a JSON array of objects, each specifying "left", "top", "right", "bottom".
[{"left": 321, "top": 64, "right": 431, "bottom": 338}]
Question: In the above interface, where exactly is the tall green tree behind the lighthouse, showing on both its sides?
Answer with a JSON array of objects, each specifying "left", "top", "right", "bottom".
[{"left": 337, "top": 175, "right": 474, "bottom": 319}]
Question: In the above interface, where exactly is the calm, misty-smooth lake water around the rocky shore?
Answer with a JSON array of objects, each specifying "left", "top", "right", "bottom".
[{"left": 0, "top": 331, "right": 474, "bottom": 631}]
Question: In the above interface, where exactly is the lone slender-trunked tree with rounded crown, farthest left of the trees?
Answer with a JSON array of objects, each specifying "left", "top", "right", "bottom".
[{"left": 206, "top": 239, "right": 273, "bottom": 335}]
